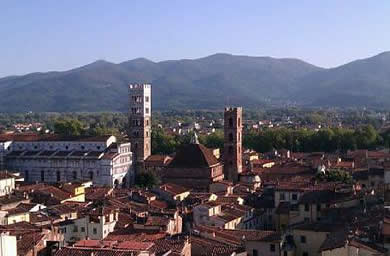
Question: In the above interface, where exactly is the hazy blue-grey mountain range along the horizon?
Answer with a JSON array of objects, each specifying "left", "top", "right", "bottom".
[{"left": 0, "top": 52, "right": 390, "bottom": 112}]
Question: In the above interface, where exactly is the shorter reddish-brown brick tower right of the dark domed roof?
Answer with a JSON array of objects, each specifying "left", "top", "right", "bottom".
[{"left": 223, "top": 107, "right": 242, "bottom": 182}]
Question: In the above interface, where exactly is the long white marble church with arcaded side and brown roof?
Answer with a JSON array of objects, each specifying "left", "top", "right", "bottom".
[{"left": 0, "top": 134, "right": 134, "bottom": 186}]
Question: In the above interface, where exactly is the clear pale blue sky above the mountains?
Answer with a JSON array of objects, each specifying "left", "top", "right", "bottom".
[{"left": 0, "top": 0, "right": 390, "bottom": 77}]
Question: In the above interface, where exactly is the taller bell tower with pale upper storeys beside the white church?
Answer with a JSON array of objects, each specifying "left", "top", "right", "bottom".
[{"left": 129, "top": 84, "right": 152, "bottom": 166}]
